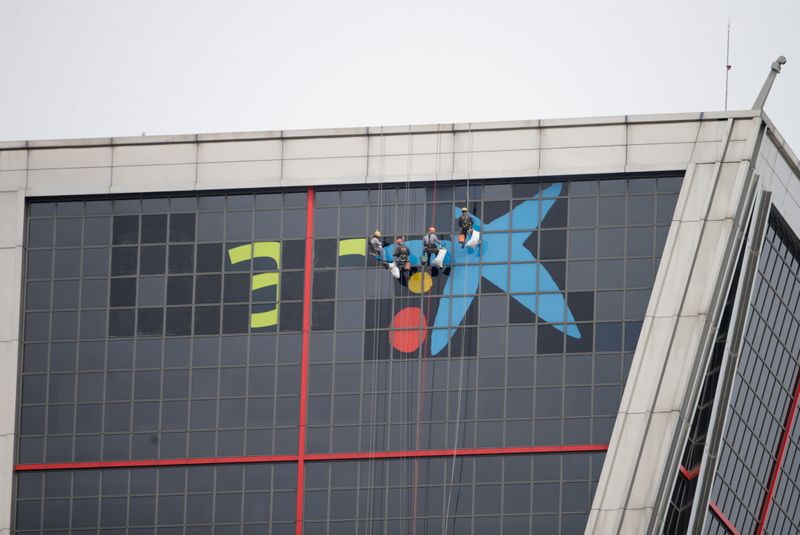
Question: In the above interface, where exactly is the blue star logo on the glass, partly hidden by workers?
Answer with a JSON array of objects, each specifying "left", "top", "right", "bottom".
[{"left": 384, "top": 184, "right": 581, "bottom": 355}]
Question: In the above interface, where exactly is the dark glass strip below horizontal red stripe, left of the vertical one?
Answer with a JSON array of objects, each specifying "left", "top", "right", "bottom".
[{"left": 15, "top": 463, "right": 297, "bottom": 535}]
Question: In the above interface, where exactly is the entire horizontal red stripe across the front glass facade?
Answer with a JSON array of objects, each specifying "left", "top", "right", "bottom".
[{"left": 14, "top": 444, "right": 608, "bottom": 472}]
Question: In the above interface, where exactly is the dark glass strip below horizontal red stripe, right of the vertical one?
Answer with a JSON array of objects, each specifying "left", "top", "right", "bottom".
[{"left": 304, "top": 453, "right": 604, "bottom": 535}]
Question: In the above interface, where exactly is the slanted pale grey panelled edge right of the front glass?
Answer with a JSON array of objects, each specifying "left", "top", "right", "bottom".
[{"left": 586, "top": 118, "right": 761, "bottom": 534}]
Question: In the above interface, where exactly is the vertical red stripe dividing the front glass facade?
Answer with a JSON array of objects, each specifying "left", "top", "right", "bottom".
[{"left": 294, "top": 187, "right": 314, "bottom": 535}]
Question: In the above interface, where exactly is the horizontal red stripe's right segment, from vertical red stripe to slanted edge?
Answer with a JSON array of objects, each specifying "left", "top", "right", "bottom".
[{"left": 305, "top": 444, "right": 608, "bottom": 461}]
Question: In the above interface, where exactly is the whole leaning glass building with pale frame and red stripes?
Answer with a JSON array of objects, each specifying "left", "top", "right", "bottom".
[{"left": 0, "top": 110, "right": 800, "bottom": 534}]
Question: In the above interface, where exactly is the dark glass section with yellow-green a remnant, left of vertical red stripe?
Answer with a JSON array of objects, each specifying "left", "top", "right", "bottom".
[{"left": 18, "top": 192, "right": 306, "bottom": 463}]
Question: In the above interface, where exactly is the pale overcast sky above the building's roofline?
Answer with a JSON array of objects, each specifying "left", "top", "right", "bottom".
[{"left": 0, "top": 0, "right": 800, "bottom": 153}]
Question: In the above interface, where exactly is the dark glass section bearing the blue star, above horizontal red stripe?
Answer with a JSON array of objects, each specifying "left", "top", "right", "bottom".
[{"left": 307, "top": 177, "right": 680, "bottom": 453}]
